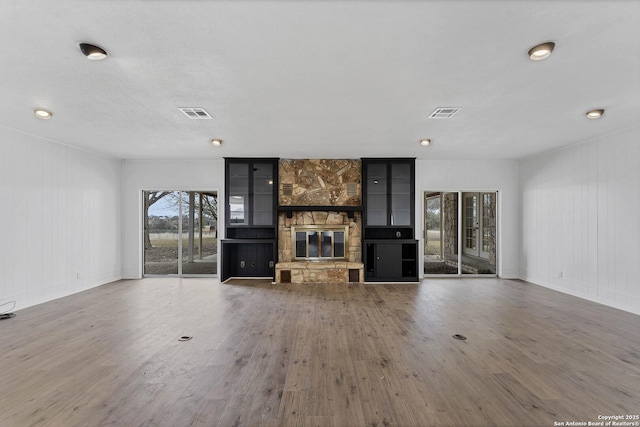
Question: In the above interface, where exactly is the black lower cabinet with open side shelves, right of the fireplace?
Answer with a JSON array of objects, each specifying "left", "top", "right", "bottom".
[{"left": 363, "top": 239, "right": 418, "bottom": 282}]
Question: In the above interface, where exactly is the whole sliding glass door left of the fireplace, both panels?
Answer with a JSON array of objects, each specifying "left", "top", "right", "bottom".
[{"left": 142, "top": 191, "right": 218, "bottom": 276}]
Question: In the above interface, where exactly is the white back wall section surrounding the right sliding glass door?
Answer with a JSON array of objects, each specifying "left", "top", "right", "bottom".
[{"left": 416, "top": 160, "right": 520, "bottom": 278}]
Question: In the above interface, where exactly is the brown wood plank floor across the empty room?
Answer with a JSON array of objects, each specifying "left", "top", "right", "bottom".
[{"left": 0, "top": 278, "right": 640, "bottom": 427}]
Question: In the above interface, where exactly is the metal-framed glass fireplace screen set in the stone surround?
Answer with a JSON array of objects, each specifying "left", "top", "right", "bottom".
[{"left": 291, "top": 225, "right": 349, "bottom": 261}]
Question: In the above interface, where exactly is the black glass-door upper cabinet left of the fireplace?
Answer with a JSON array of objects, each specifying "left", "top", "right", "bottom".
[{"left": 225, "top": 158, "right": 278, "bottom": 238}]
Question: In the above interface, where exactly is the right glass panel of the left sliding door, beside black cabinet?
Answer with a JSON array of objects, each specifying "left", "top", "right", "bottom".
[{"left": 182, "top": 191, "right": 218, "bottom": 274}]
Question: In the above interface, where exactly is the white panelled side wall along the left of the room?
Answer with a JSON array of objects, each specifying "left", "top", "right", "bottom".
[{"left": 0, "top": 127, "right": 122, "bottom": 313}]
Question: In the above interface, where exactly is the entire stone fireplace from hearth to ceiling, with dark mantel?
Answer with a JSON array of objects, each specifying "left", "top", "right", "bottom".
[{"left": 275, "top": 159, "right": 364, "bottom": 283}]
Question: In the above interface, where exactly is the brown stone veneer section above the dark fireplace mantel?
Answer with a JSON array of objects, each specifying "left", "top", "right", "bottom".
[{"left": 278, "top": 159, "right": 362, "bottom": 206}]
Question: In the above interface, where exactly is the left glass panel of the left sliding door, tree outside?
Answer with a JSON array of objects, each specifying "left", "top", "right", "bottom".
[{"left": 143, "top": 191, "right": 180, "bottom": 274}]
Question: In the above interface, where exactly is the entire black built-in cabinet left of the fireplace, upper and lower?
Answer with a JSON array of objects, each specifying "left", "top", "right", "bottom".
[{"left": 221, "top": 158, "right": 278, "bottom": 280}]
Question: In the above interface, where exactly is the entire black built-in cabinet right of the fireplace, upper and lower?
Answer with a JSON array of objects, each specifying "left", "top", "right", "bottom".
[{"left": 362, "top": 158, "right": 418, "bottom": 281}]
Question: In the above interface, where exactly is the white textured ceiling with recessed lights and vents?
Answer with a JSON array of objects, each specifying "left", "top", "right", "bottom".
[{"left": 0, "top": 0, "right": 640, "bottom": 159}]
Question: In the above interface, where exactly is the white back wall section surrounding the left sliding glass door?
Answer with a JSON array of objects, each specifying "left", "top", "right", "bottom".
[{"left": 122, "top": 159, "right": 224, "bottom": 278}]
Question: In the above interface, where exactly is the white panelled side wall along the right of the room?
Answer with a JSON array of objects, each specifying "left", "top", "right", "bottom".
[{"left": 520, "top": 129, "right": 640, "bottom": 314}]
